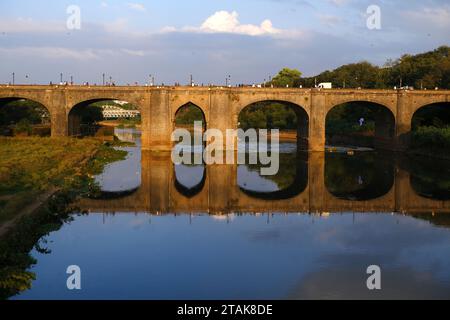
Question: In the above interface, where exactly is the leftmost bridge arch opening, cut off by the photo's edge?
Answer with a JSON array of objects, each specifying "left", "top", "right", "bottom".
[{"left": 0, "top": 96, "right": 54, "bottom": 136}]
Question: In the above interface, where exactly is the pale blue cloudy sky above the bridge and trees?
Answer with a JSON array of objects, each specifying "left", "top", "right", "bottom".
[{"left": 0, "top": 0, "right": 450, "bottom": 84}]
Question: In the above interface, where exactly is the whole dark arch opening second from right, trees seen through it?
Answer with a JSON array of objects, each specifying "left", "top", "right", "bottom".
[{"left": 325, "top": 99, "right": 396, "bottom": 150}]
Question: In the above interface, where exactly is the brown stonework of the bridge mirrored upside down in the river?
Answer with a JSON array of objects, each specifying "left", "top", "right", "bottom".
[{"left": 78, "top": 152, "right": 450, "bottom": 214}]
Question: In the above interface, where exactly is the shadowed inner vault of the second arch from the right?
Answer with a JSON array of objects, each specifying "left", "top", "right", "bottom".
[{"left": 325, "top": 99, "right": 396, "bottom": 149}]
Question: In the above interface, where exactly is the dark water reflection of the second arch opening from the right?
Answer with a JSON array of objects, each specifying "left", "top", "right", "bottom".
[{"left": 324, "top": 153, "right": 395, "bottom": 201}]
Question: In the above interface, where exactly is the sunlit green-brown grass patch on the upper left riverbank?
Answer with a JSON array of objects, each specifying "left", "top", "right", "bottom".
[{"left": 0, "top": 138, "right": 126, "bottom": 226}]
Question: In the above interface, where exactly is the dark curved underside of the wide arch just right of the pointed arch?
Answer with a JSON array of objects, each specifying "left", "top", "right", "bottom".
[{"left": 236, "top": 99, "right": 309, "bottom": 150}]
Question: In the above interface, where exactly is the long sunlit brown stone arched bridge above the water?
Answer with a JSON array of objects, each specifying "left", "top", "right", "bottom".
[{"left": 0, "top": 85, "right": 450, "bottom": 151}]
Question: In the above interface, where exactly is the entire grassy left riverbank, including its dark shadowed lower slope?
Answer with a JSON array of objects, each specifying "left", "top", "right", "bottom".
[{"left": 0, "top": 138, "right": 126, "bottom": 300}]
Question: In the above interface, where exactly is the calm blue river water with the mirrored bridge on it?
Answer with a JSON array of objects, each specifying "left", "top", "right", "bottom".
[{"left": 13, "top": 129, "right": 450, "bottom": 299}]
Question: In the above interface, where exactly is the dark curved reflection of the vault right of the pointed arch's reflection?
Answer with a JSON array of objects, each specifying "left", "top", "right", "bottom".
[{"left": 239, "top": 153, "right": 308, "bottom": 201}]
